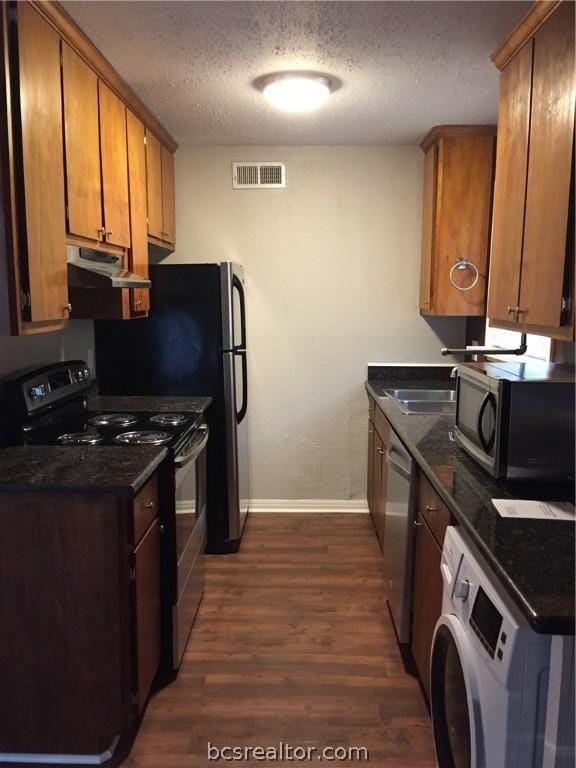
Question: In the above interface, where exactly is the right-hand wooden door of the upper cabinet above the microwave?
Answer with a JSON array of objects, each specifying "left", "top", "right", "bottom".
[{"left": 519, "top": 3, "right": 575, "bottom": 328}]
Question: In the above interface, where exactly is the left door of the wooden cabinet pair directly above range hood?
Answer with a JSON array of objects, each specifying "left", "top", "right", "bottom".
[{"left": 62, "top": 42, "right": 103, "bottom": 240}]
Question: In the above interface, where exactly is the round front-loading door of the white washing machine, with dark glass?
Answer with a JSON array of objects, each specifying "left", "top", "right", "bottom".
[{"left": 430, "top": 615, "right": 486, "bottom": 768}]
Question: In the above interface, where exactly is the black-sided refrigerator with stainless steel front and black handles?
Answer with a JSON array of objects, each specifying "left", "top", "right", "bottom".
[{"left": 95, "top": 262, "right": 250, "bottom": 554}]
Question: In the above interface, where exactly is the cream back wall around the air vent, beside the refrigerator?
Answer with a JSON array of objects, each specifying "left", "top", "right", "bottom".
[{"left": 169, "top": 146, "right": 464, "bottom": 500}]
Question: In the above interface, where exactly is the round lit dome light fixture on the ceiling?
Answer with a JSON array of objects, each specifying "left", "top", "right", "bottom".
[{"left": 254, "top": 70, "right": 340, "bottom": 112}]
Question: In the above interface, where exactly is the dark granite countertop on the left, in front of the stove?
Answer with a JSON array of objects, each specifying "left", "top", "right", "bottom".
[{"left": 0, "top": 445, "right": 167, "bottom": 498}]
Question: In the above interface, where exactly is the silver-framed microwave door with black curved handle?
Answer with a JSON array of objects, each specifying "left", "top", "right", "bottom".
[{"left": 455, "top": 369, "right": 502, "bottom": 477}]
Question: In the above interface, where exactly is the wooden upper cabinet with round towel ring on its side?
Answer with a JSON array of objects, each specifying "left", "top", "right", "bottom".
[{"left": 420, "top": 125, "right": 496, "bottom": 316}]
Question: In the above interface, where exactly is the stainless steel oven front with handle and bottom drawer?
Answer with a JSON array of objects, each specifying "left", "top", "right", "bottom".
[{"left": 172, "top": 426, "right": 209, "bottom": 669}]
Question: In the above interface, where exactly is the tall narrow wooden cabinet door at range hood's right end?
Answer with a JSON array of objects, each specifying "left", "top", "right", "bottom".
[{"left": 126, "top": 111, "right": 150, "bottom": 313}]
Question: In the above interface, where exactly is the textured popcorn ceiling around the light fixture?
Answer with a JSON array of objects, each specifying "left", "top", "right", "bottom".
[{"left": 63, "top": 0, "right": 530, "bottom": 145}]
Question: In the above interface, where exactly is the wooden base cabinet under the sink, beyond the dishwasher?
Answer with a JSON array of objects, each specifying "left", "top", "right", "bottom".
[{"left": 367, "top": 398, "right": 390, "bottom": 548}]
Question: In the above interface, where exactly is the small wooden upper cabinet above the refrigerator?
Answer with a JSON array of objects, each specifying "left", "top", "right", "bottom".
[{"left": 146, "top": 131, "right": 176, "bottom": 248}]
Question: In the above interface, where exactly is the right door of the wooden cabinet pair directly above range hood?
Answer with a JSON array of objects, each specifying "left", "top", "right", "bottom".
[{"left": 98, "top": 81, "right": 130, "bottom": 248}]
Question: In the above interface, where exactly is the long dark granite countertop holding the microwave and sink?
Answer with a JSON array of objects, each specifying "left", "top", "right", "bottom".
[{"left": 366, "top": 370, "right": 575, "bottom": 635}]
